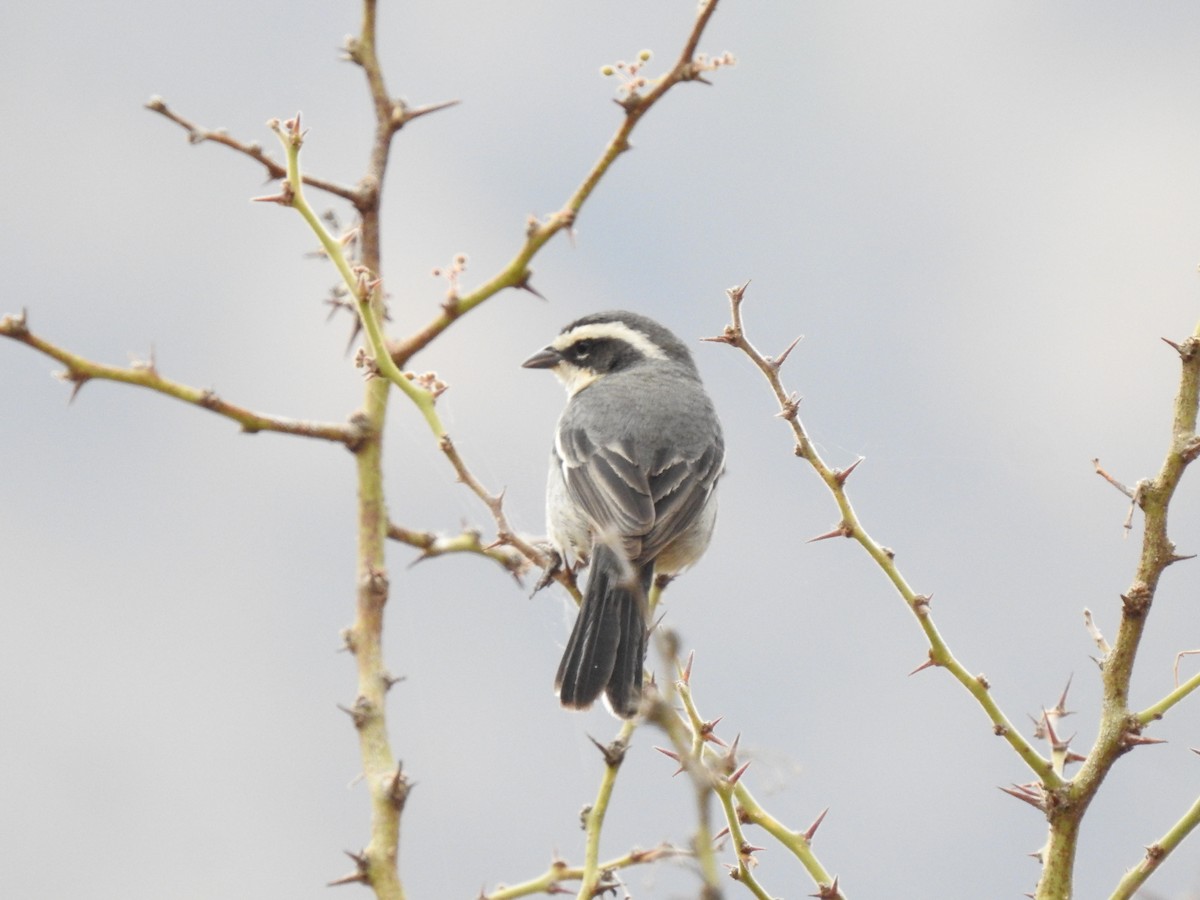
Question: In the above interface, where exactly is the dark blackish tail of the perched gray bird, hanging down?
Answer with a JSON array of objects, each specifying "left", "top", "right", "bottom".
[{"left": 554, "top": 544, "right": 654, "bottom": 719}]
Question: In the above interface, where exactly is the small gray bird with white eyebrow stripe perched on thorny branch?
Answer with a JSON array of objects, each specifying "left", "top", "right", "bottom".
[{"left": 522, "top": 311, "right": 725, "bottom": 719}]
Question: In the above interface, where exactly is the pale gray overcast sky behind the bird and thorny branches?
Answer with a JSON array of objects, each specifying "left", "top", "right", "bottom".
[{"left": 0, "top": 0, "right": 1200, "bottom": 900}]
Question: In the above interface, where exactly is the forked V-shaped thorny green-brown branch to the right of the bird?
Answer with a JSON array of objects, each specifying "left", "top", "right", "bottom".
[{"left": 707, "top": 284, "right": 1200, "bottom": 900}]
